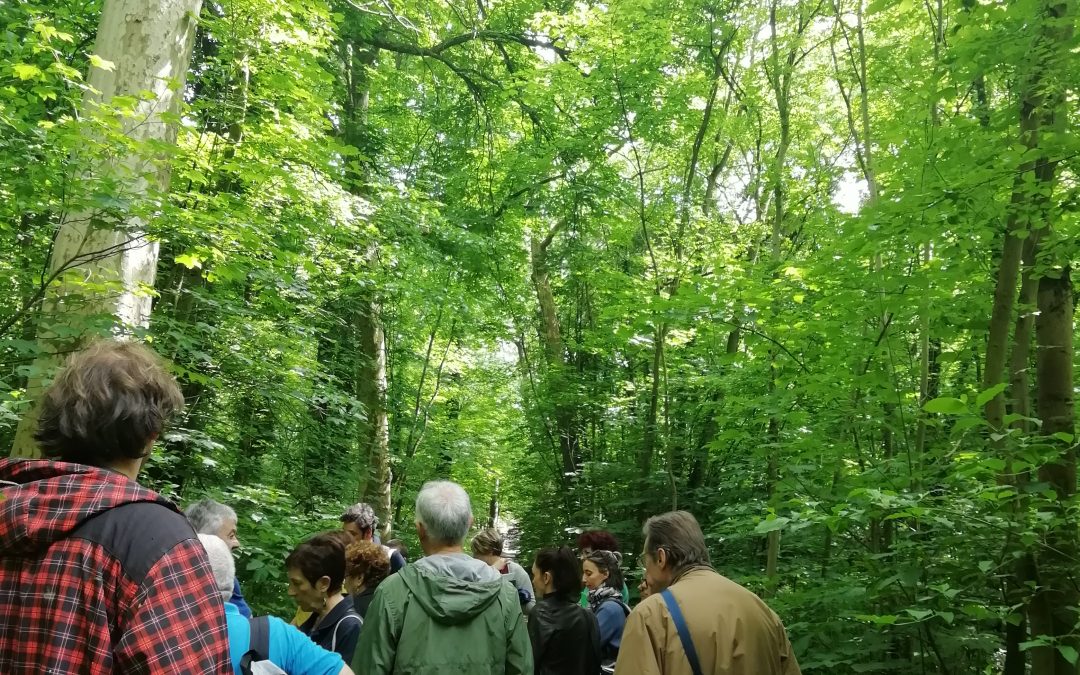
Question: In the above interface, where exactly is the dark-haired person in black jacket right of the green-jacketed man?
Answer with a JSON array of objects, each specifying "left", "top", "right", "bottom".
[{"left": 529, "top": 546, "right": 600, "bottom": 675}]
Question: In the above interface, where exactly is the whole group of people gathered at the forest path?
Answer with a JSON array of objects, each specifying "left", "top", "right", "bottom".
[{"left": 0, "top": 341, "right": 799, "bottom": 675}]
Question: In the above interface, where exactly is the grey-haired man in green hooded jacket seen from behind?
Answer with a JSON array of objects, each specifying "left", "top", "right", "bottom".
[{"left": 352, "top": 482, "right": 532, "bottom": 675}]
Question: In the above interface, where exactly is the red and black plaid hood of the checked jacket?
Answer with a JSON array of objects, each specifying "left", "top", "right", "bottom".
[{"left": 0, "top": 459, "right": 171, "bottom": 555}]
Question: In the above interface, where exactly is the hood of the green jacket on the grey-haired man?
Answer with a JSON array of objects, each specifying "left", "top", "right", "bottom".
[{"left": 397, "top": 553, "right": 508, "bottom": 625}]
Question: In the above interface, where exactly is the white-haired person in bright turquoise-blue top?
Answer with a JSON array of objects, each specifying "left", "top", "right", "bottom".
[{"left": 199, "top": 535, "right": 353, "bottom": 675}]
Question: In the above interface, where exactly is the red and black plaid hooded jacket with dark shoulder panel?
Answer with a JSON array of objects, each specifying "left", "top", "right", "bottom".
[{"left": 0, "top": 459, "right": 232, "bottom": 675}]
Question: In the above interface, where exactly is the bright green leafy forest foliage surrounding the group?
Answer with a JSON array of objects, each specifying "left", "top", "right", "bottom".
[{"left": 0, "top": 0, "right": 1080, "bottom": 675}]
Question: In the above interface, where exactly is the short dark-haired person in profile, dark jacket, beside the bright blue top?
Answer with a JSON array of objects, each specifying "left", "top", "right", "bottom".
[{"left": 285, "top": 531, "right": 364, "bottom": 663}]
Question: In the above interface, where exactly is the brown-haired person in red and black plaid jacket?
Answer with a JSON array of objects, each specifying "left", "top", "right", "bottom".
[{"left": 0, "top": 341, "right": 232, "bottom": 675}]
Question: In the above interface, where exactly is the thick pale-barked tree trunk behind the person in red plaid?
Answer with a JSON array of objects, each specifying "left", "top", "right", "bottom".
[{"left": 12, "top": 0, "right": 202, "bottom": 457}]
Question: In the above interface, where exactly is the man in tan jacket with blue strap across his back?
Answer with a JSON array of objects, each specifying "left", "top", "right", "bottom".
[{"left": 615, "top": 511, "right": 801, "bottom": 675}]
